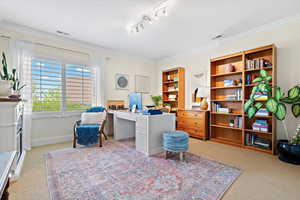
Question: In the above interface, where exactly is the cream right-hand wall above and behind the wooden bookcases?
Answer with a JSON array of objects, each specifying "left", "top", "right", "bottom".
[{"left": 157, "top": 20, "right": 300, "bottom": 141}]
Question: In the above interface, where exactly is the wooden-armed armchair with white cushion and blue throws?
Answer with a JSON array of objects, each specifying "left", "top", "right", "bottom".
[{"left": 73, "top": 107, "right": 107, "bottom": 148}]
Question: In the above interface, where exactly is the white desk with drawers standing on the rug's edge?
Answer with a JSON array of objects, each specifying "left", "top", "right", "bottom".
[{"left": 114, "top": 111, "right": 176, "bottom": 156}]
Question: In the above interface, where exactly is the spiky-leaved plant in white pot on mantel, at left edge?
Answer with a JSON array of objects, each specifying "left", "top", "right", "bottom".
[{"left": 0, "top": 53, "right": 11, "bottom": 97}]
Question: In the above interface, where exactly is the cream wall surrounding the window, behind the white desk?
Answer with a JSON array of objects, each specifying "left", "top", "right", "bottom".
[{"left": 0, "top": 23, "right": 158, "bottom": 146}]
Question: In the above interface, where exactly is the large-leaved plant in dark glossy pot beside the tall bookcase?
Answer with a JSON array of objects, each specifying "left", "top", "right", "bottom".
[{"left": 244, "top": 70, "right": 300, "bottom": 164}]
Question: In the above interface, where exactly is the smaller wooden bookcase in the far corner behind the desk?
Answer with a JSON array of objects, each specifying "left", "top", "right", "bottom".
[{"left": 162, "top": 67, "right": 185, "bottom": 113}]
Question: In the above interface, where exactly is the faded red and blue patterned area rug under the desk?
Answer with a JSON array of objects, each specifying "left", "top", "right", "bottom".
[{"left": 45, "top": 140, "right": 241, "bottom": 200}]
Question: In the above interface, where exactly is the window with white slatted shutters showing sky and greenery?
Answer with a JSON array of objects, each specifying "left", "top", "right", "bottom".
[{"left": 31, "top": 59, "right": 95, "bottom": 113}]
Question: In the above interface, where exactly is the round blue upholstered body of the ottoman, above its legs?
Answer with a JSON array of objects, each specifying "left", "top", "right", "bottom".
[{"left": 163, "top": 131, "right": 189, "bottom": 152}]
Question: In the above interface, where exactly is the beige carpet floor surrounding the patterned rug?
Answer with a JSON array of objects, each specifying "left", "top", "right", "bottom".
[{"left": 9, "top": 139, "right": 300, "bottom": 200}]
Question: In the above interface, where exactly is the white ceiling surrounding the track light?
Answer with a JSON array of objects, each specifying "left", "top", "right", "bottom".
[{"left": 0, "top": 0, "right": 300, "bottom": 59}]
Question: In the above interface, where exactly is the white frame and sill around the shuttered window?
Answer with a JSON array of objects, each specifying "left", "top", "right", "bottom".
[{"left": 30, "top": 56, "right": 97, "bottom": 119}]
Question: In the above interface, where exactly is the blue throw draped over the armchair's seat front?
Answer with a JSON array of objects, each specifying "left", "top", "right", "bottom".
[{"left": 76, "top": 124, "right": 101, "bottom": 145}]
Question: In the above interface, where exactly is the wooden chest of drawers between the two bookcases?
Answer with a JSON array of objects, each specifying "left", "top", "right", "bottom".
[{"left": 177, "top": 110, "right": 209, "bottom": 140}]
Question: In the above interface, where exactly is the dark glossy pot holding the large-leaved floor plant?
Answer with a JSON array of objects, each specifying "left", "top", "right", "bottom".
[{"left": 277, "top": 140, "right": 300, "bottom": 165}]
